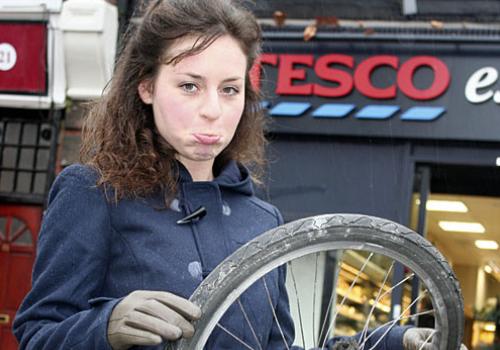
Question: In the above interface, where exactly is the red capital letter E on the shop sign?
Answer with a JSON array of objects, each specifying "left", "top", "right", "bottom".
[{"left": 276, "top": 55, "right": 314, "bottom": 95}]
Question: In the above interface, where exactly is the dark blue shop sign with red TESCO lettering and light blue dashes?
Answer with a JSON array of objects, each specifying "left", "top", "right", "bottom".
[{"left": 251, "top": 43, "right": 500, "bottom": 142}]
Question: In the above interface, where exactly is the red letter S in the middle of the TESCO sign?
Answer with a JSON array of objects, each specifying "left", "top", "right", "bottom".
[{"left": 313, "top": 55, "right": 354, "bottom": 97}]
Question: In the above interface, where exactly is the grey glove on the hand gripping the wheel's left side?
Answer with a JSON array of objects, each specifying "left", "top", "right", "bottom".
[{"left": 108, "top": 290, "right": 201, "bottom": 350}]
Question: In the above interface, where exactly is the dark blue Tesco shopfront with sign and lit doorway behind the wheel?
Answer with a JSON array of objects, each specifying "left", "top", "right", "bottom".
[{"left": 256, "top": 27, "right": 500, "bottom": 346}]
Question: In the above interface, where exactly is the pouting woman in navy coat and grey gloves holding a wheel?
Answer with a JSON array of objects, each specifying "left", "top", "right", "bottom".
[{"left": 14, "top": 0, "right": 438, "bottom": 350}]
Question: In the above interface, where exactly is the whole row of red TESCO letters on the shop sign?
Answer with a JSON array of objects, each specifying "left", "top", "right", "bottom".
[{"left": 252, "top": 54, "right": 450, "bottom": 100}]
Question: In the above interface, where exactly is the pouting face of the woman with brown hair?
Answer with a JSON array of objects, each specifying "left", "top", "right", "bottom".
[{"left": 139, "top": 35, "right": 247, "bottom": 176}]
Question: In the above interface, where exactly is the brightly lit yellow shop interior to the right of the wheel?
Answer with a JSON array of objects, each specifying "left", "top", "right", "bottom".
[{"left": 415, "top": 193, "right": 500, "bottom": 349}]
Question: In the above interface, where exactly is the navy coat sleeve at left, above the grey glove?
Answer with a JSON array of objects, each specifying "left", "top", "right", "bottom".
[{"left": 13, "top": 166, "right": 119, "bottom": 350}]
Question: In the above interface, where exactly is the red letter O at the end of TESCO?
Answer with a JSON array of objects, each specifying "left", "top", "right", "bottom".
[{"left": 398, "top": 56, "right": 450, "bottom": 100}]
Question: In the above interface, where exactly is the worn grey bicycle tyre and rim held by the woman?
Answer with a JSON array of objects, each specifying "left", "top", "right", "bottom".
[{"left": 174, "top": 215, "right": 462, "bottom": 349}]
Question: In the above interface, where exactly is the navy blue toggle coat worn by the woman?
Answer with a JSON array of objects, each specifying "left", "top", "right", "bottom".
[{"left": 14, "top": 163, "right": 408, "bottom": 350}]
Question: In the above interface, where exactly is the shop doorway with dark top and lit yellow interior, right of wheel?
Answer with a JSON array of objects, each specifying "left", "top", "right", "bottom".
[{"left": 410, "top": 164, "right": 500, "bottom": 349}]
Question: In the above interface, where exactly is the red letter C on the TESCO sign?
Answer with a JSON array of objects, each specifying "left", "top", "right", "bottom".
[{"left": 354, "top": 55, "right": 399, "bottom": 99}]
